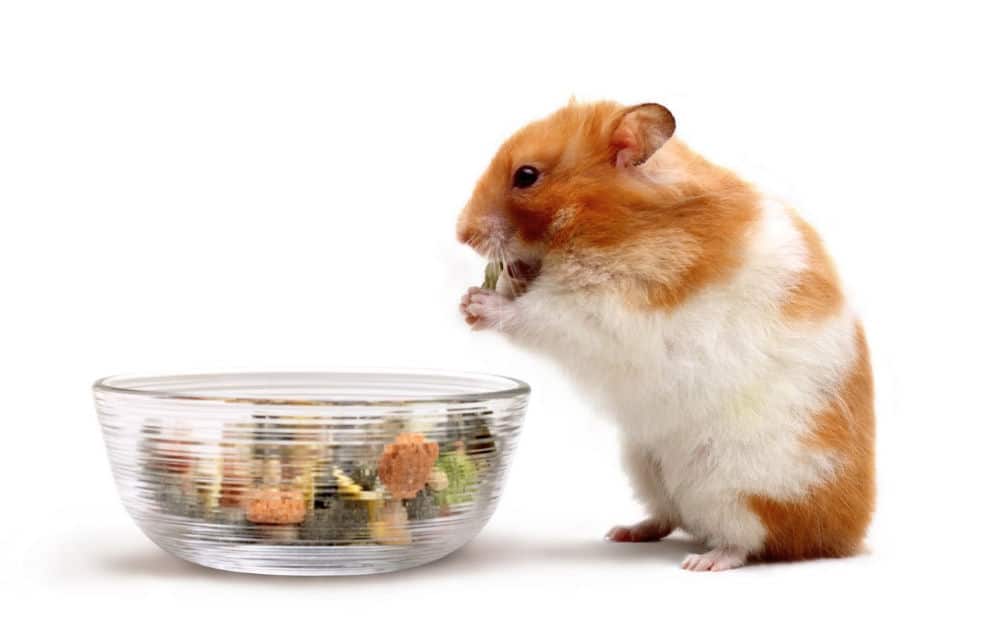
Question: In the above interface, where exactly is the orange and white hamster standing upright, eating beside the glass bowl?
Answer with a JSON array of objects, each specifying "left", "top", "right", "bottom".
[{"left": 458, "top": 102, "right": 875, "bottom": 571}]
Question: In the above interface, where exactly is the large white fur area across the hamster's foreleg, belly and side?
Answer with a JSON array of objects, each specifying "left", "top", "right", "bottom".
[{"left": 504, "top": 195, "right": 857, "bottom": 552}]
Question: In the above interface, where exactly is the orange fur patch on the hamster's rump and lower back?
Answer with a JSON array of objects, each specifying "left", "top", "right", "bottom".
[{"left": 748, "top": 325, "right": 875, "bottom": 560}]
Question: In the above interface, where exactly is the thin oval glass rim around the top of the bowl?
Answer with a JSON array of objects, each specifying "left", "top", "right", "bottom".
[{"left": 91, "top": 367, "right": 531, "bottom": 406}]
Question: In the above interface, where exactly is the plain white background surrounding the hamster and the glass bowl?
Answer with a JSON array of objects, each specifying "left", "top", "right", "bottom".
[{"left": 0, "top": 0, "right": 1000, "bottom": 630}]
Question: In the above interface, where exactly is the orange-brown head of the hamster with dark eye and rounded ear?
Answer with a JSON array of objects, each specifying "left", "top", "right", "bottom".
[{"left": 458, "top": 102, "right": 675, "bottom": 292}]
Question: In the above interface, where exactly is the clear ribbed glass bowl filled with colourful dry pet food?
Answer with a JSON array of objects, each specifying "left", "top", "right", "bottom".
[{"left": 94, "top": 371, "right": 529, "bottom": 575}]
